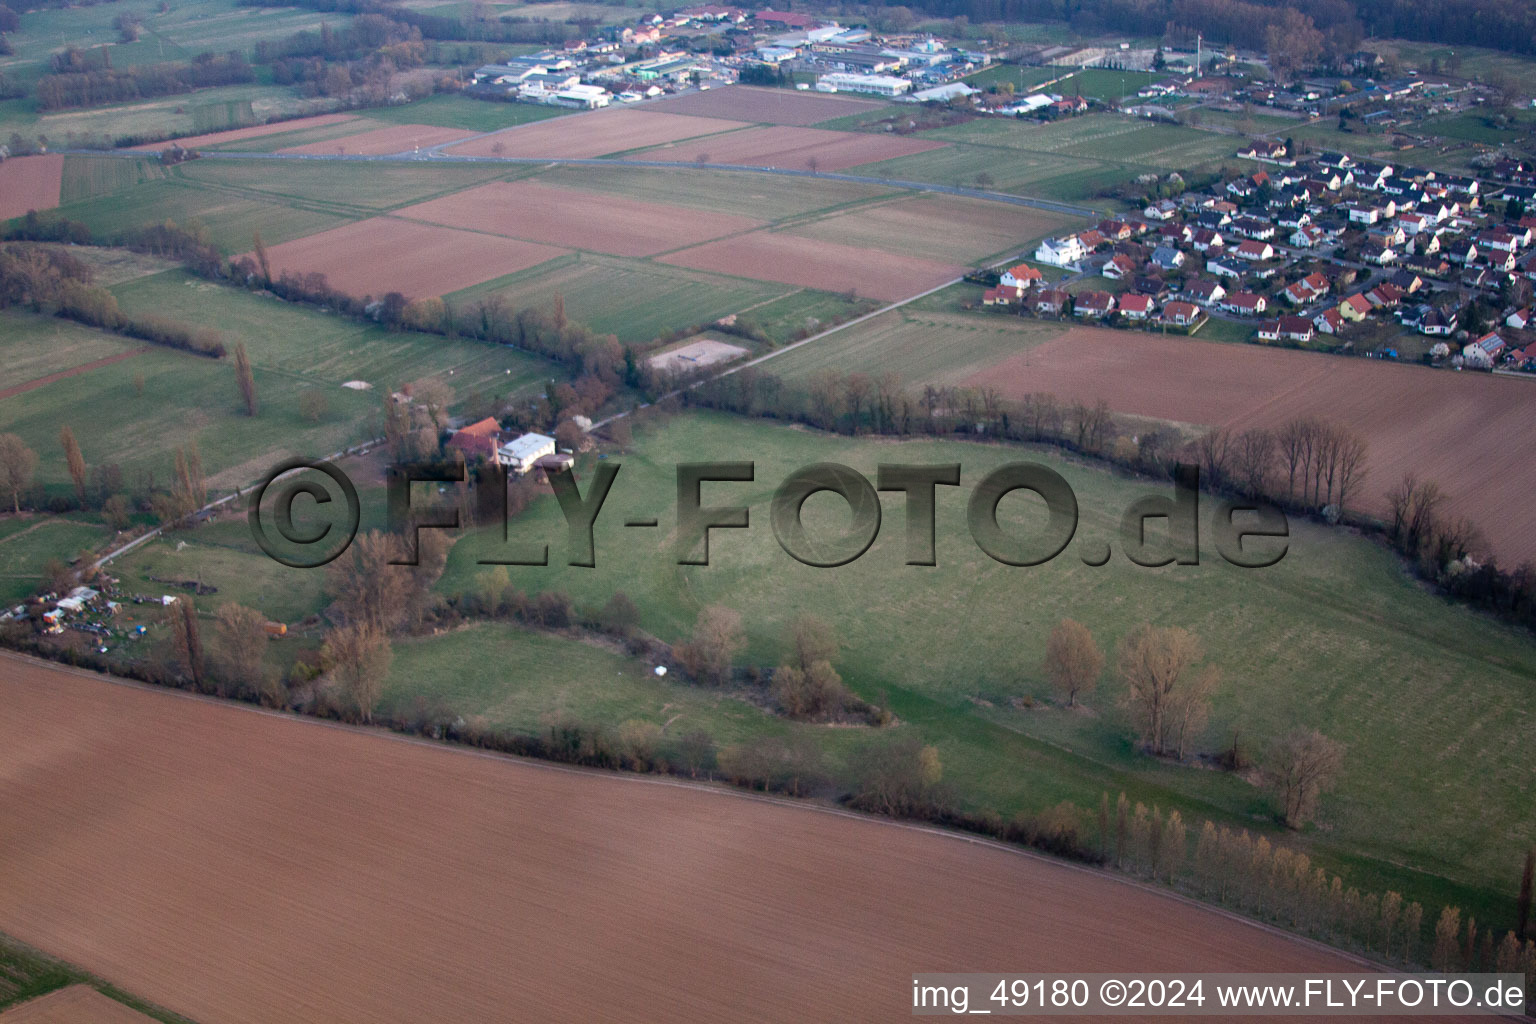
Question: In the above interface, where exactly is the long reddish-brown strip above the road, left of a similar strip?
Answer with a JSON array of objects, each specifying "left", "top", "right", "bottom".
[{"left": 444, "top": 107, "right": 746, "bottom": 158}]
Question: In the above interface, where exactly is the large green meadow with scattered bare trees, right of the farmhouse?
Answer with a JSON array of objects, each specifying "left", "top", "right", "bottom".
[{"left": 439, "top": 411, "right": 1536, "bottom": 906}]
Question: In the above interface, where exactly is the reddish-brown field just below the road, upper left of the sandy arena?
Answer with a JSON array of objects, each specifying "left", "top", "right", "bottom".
[{"left": 396, "top": 181, "right": 762, "bottom": 256}]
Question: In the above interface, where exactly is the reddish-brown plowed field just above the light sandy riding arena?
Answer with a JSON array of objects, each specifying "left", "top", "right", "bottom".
[{"left": 660, "top": 232, "right": 965, "bottom": 302}]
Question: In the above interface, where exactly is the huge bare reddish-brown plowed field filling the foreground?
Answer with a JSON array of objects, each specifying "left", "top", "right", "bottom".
[{"left": 0, "top": 656, "right": 1474, "bottom": 1024}]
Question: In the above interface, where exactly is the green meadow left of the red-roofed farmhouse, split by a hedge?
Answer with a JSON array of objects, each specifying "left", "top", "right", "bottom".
[{"left": 0, "top": 270, "right": 553, "bottom": 503}]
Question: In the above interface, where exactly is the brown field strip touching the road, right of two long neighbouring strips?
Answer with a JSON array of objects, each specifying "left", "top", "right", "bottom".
[{"left": 634, "top": 126, "right": 948, "bottom": 170}]
